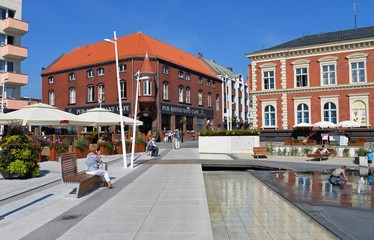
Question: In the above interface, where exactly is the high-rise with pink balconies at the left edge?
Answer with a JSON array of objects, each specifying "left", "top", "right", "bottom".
[{"left": 0, "top": 0, "right": 30, "bottom": 112}]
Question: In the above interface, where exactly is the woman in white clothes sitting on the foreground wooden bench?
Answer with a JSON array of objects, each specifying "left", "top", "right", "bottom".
[{"left": 85, "top": 144, "right": 113, "bottom": 189}]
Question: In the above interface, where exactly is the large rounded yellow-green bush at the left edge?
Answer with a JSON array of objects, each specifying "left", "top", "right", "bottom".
[{"left": 0, "top": 124, "right": 40, "bottom": 179}]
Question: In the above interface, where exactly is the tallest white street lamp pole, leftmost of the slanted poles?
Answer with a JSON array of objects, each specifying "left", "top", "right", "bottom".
[{"left": 104, "top": 31, "right": 127, "bottom": 168}]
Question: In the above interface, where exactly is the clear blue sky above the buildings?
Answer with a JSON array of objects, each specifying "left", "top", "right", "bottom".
[{"left": 22, "top": 0, "right": 374, "bottom": 98}]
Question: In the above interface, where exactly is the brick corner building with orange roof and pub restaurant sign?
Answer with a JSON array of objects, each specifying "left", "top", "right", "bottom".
[{"left": 42, "top": 32, "right": 222, "bottom": 135}]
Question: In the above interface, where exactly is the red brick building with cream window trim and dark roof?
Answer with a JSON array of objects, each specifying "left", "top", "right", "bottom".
[{"left": 246, "top": 27, "right": 374, "bottom": 142}]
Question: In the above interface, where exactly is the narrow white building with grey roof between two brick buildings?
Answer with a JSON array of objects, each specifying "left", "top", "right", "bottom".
[{"left": 198, "top": 53, "right": 252, "bottom": 129}]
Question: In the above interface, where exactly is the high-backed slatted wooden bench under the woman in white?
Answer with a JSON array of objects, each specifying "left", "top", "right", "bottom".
[{"left": 60, "top": 152, "right": 101, "bottom": 198}]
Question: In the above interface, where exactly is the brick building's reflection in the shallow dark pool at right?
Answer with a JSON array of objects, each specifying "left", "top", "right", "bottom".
[{"left": 274, "top": 168, "right": 374, "bottom": 209}]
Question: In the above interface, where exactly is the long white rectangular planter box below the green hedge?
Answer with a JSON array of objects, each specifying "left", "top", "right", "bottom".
[{"left": 198, "top": 136, "right": 260, "bottom": 153}]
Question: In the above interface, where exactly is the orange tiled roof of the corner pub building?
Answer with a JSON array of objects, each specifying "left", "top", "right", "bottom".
[{"left": 43, "top": 32, "right": 216, "bottom": 78}]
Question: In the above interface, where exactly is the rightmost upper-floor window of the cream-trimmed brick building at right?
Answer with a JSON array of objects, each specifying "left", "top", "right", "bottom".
[{"left": 347, "top": 53, "right": 368, "bottom": 83}]
